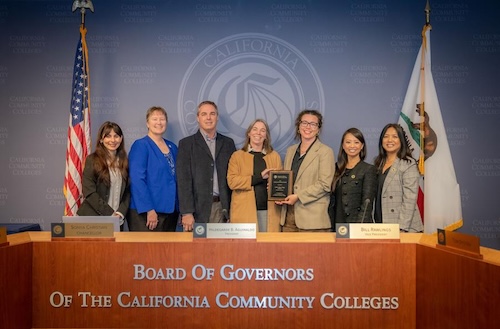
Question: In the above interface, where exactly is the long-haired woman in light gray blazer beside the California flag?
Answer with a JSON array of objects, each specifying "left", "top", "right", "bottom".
[{"left": 375, "top": 123, "right": 424, "bottom": 232}]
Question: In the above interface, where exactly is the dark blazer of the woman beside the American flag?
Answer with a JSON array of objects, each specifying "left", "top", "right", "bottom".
[{"left": 77, "top": 153, "right": 130, "bottom": 216}]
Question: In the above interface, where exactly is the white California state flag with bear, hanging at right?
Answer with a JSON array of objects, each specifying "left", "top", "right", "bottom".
[{"left": 399, "top": 24, "right": 463, "bottom": 234}]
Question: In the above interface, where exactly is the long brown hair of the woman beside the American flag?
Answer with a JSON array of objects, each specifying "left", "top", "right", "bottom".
[{"left": 94, "top": 121, "right": 128, "bottom": 186}]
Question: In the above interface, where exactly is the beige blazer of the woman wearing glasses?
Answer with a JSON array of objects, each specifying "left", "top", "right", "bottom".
[{"left": 281, "top": 140, "right": 335, "bottom": 230}]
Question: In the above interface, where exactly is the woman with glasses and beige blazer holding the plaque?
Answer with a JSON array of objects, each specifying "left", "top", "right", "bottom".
[{"left": 276, "top": 110, "right": 335, "bottom": 232}]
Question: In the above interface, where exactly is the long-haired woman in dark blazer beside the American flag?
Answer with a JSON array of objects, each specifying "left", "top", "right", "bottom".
[{"left": 77, "top": 121, "right": 130, "bottom": 231}]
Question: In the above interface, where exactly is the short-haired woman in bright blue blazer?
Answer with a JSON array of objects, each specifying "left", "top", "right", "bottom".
[{"left": 127, "top": 106, "right": 179, "bottom": 232}]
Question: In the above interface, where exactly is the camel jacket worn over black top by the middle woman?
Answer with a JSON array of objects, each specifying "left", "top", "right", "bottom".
[{"left": 227, "top": 150, "right": 283, "bottom": 232}]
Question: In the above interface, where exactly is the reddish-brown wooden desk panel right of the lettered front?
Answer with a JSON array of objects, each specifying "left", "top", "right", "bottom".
[{"left": 417, "top": 245, "right": 500, "bottom": 329}]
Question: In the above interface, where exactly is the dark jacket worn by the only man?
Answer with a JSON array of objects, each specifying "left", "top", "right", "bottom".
[{"left": 177, "top": 130, "right": 236, "bottom": 223}]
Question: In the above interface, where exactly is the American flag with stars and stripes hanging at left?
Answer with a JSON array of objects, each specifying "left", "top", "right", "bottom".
[{"left": 63, "top": 26, "right": 91, "bottom": 216}]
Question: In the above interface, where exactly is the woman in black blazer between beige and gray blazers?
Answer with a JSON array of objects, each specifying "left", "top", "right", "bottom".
[{"left": 329, "top": 128, "right": 377, "bottom": 231}]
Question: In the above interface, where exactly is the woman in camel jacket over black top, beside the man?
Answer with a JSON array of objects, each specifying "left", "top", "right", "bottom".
[{"left": 227, "top": 119, "right": 283, "bottom": 232}]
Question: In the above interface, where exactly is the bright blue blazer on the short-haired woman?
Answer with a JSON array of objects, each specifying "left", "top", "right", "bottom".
[{"left": 128, "top": 135, "right": 178, "bottom": 214}]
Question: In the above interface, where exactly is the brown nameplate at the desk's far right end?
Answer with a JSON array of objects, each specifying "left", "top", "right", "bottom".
[{"left": 436, "top": 228, "right": 483, "bottom": 259}]
